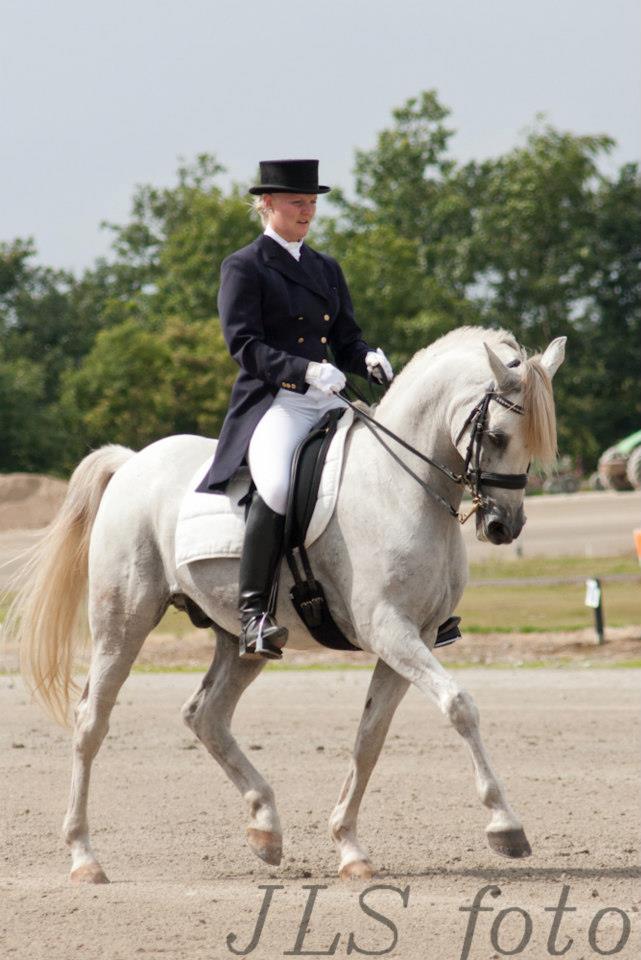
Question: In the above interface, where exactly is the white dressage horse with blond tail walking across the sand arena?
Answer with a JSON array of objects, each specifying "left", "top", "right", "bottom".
[{"left": 7, "top": 328, "right": 564, "bottom": 883}]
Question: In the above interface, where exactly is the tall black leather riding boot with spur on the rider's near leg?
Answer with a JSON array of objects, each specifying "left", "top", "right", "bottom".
[{"left": 238, "top": 493, "right": 287, "bottom": 660}]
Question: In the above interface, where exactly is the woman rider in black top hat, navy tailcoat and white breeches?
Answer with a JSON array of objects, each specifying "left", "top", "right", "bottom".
[{"left": 199, "top": 160, "right": 393, "bottom": 659}]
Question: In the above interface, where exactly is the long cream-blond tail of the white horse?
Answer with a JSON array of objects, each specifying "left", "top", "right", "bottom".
[{"left": 4, "top": 444, "right": 134, "bottom": 725}]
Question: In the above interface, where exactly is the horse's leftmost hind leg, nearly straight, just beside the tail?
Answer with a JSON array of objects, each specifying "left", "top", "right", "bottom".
[{"left": 62, "top": 595, "right": 166, "bottom": 883}]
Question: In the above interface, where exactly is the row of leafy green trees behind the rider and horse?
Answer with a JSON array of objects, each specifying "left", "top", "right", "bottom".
[{"left": 0, "top": 91, "right": 641, "bottom": 473}]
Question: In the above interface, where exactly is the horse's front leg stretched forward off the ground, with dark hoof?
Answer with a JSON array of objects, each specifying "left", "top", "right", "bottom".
[{"left": 372, "top": 610, "right": 532, "bottom": 857}]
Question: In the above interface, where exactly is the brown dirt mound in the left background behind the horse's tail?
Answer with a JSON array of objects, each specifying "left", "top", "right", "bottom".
[{"left": 0, "top": 473, "right": 67, "bottom": 531}]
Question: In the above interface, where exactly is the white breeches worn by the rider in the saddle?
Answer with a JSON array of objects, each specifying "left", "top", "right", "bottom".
[{"left": 247, "top": 387, "right": 346, "bottom": 514}]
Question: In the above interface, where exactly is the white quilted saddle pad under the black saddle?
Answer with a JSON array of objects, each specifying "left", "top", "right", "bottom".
[{"left": 176, "top": 409, "right": 354, "bottom": 567}]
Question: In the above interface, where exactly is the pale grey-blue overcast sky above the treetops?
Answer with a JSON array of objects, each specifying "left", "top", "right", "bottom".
[{"left": 0, "top": 0, "right": 641, "bottom": 271}]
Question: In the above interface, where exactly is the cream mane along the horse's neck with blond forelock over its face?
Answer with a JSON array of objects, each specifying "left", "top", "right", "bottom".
[{"left": 382, "top": 327, "right": 557, "bottom": 464}]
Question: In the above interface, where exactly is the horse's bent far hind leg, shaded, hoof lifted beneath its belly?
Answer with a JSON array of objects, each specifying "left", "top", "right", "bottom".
[{"left": 182, "top": 630, "right": 283, "bottom": 865}]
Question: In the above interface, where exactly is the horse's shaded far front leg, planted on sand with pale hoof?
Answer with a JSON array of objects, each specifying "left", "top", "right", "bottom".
[{"left": 329, "top": 660, "right": 409, "bottom": 880}]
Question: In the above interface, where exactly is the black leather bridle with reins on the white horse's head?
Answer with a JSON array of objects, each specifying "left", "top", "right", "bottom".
[{"left": 340, "top": 388, "right": 529, "bottom": 524}]
